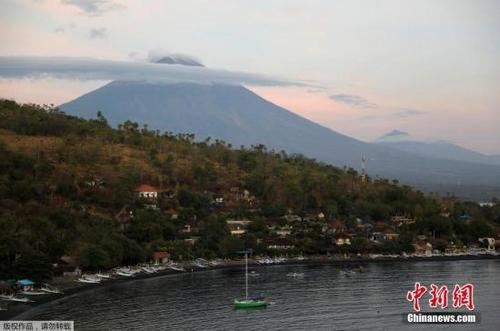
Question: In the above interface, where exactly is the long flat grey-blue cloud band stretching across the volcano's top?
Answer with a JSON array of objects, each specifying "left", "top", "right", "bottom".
[{"left": 0, "top": 56, "right": 311, "bottom": 86}]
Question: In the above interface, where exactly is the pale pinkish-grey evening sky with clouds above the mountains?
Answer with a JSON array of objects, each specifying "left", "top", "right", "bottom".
[{"left": 0, "top": 0, "right": 500, "bottom": 154}]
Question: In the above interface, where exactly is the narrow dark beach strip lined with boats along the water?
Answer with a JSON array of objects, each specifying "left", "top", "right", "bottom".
[{"left": 0, "top": 255, "right": 500, "bottom": 321}]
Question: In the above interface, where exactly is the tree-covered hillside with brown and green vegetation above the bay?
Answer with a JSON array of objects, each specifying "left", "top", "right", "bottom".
[{"left": 0, "top": 100, "right": 500, "bottom": 279}]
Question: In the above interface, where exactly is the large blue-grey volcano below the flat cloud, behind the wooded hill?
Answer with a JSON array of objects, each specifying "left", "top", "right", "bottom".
[{"left": 60, "top": 81, "right": 500, "bottom": 200}]
